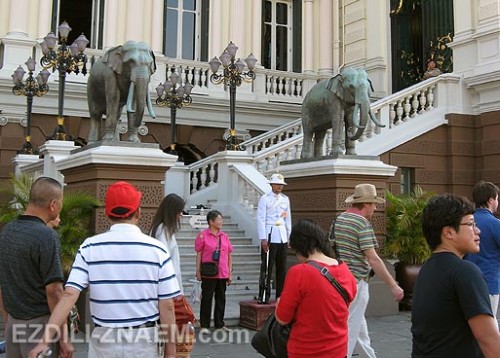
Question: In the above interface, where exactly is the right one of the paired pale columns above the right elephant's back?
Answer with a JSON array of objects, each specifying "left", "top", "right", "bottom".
[{"left": 318, "top": 0, "right": 334, "bottom": 77}]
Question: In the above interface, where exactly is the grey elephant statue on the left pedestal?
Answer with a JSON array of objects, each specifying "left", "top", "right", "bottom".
[{"left": 87, "top": 41, "right": 156, "bottom": 143}]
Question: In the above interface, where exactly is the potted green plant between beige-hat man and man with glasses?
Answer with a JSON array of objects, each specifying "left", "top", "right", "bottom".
[{"left": 382, "top": 186, "right": 433, "bottom": 310}]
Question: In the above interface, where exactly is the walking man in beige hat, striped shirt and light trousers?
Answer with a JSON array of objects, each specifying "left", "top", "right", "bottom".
[{"left": 330, "top": 184, "right": 403, "bottom": 358}]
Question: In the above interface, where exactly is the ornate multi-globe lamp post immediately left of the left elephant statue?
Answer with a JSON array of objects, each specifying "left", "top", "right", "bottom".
[{"left": 40, "top": 21, "right": 89, "bottom": 140}]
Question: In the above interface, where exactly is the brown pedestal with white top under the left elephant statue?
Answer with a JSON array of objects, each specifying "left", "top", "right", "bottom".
[{"left": 57, "top": 141, "right": 177, "bottom": 233}]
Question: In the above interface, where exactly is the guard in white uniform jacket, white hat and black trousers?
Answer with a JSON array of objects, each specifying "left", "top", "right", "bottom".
[{"left": 257, "top": 174, "right": 292, "bottom": 303}]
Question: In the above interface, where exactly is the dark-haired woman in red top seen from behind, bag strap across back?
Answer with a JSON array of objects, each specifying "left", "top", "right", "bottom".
[{"left": 276, "top": 220, "right": 356, "bottom": 358}]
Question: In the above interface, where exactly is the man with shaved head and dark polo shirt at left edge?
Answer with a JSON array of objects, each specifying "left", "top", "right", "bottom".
[{"left": 0, "top": 177, "right": 73, "bottom": 358}]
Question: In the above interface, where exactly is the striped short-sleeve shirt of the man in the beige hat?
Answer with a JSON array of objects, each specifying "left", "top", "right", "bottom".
[{"left": 335, "top": 211, "right": 378, "bottom": 281}]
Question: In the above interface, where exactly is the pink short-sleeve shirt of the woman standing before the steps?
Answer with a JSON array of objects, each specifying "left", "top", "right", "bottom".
[{"left": 194, "top": 229, "right": 233, "bottom": 278}]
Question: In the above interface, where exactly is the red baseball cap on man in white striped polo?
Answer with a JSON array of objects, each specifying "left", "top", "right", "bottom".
[{"left": 106, "top": 181, "right": 142, "bottom": 218}]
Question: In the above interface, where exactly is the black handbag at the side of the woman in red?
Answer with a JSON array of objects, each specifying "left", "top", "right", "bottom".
[{"left": 251, "top": 313, "right": 292, "bottom": 358}]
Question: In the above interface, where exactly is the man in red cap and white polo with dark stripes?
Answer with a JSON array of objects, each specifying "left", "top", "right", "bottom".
[{"left": 30, "top": 181, "right": 180, "bottom": 358}]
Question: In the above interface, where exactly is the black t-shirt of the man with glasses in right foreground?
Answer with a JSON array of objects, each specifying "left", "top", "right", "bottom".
[{"left": 411, "top": 252, "right": 493, "bottom": 358}]
